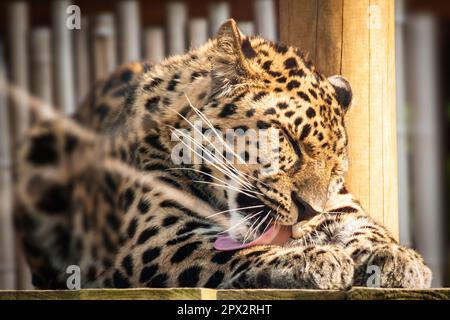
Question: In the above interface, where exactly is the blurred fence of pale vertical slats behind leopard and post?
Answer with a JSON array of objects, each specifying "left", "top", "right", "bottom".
[{"left": 0, "top": 0, "right": 450, "bottom": 290}]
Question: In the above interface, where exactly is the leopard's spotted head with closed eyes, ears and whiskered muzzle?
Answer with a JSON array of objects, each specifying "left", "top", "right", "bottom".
[{"left": 178, "top": 20, "right": 352, "bottom": 245}]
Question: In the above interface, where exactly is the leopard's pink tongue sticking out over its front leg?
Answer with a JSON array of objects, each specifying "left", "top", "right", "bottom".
[{"left": 214, "top": 224, "right": 292, "bottom": 251}]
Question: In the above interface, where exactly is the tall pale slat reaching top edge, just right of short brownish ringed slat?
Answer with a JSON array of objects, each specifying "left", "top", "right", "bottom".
[{"left": 117, "top": 0, "right": 141, "bottom": 64}]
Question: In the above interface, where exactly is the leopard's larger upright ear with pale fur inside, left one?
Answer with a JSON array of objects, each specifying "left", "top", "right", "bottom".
[{"left": 213, "top": 19, "right": 257, "bottom": 93}]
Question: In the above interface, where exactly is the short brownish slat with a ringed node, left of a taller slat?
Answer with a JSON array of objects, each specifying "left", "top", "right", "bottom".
[{"left": 92, "top": 13, "right": 117, "bottom": 81}]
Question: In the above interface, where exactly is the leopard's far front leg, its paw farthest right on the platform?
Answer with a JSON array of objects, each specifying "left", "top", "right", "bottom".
[{"left": 291, "top": 189, "right": 431, "bottom": 288}]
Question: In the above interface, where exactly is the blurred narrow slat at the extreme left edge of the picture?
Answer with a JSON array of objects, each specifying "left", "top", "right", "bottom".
[{"left": 0, "top": 42, "right": 16, "bottom": 290}]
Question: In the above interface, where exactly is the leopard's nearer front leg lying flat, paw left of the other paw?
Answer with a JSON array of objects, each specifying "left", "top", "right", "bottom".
[{"left": 221, "top": 246, "right": 354, "bottom": 290}]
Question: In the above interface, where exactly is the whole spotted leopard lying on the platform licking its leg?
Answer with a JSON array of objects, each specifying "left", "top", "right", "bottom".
[{"left": 15, "top": 19, "right": 432, "bottom": 290}]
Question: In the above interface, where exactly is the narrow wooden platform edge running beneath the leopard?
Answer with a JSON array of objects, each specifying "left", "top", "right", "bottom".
[{"left": 0, "top": 288, "right": 450, "bottom": 300}]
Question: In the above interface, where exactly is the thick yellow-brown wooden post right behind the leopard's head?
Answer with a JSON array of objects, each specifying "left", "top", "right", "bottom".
[{"left": 280, "top": 0, "right": 398, "bottom": 238}]
